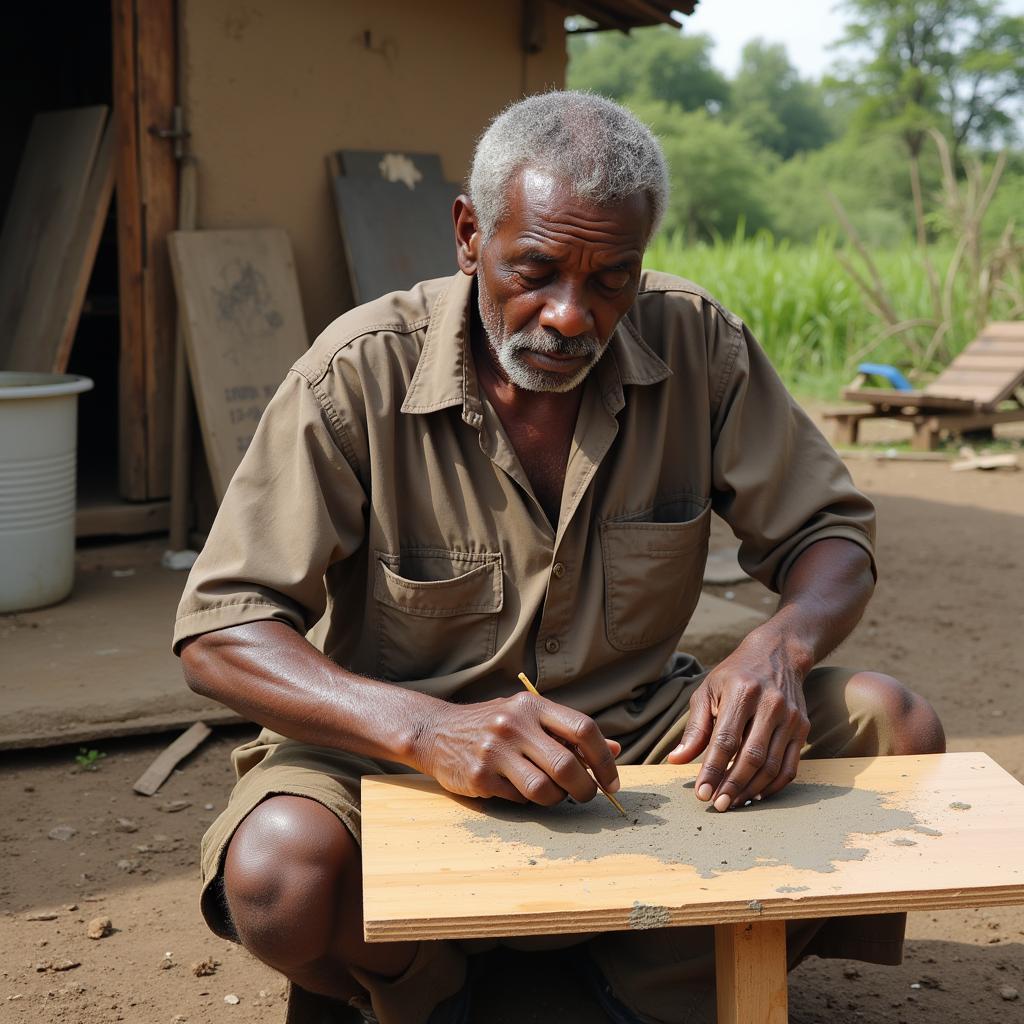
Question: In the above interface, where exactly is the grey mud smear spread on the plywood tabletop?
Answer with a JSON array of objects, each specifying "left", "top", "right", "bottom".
[{"left": 460, "top": 781, "right": 938, "bottom": 879}]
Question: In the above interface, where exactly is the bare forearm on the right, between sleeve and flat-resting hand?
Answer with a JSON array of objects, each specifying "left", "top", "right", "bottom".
[{"left": 744, "top": 538, "right": 874, "bottom": 676}]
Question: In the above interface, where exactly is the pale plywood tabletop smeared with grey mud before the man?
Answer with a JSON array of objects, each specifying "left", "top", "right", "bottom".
[{"left": 362, "top": 754, "right": 1024, "bottom": 941}]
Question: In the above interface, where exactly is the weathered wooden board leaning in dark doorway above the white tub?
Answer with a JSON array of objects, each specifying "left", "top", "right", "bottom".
[{"left": 0, "top": 106, "right": 106, "bottom": 372}]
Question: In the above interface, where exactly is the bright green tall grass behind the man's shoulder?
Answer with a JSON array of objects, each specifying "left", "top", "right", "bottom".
[{"left": 644, "top": 231, "right": 977, "bottom": 398}]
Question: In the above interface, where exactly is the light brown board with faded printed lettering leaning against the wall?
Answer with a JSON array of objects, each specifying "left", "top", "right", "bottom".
[{"left": 168, "top": 228, "right": 309, "bottom": 501}]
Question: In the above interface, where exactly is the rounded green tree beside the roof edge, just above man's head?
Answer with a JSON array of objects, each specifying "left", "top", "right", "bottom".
[{"left": 568, "top": 26, "right": 729, "bottom": 111}]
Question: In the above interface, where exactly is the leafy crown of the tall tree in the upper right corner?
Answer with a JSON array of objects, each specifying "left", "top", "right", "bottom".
[{"left": 840, "top": 0, "right": 1024, "bottom": 160}]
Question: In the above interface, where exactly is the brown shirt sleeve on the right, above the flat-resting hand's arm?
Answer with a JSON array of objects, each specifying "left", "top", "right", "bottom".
[{"left": 712, "top": 319, "right": 876, "bottom": 592}]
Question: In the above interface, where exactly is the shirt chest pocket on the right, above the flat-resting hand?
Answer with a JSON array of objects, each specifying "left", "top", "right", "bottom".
[{"left": 601, "top": 496, "right": 711, "bottom": 650}]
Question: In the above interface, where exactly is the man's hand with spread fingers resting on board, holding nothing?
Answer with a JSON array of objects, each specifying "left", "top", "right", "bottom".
[{"left": 668, "top": 636, "right": 810, "bottom": 811}]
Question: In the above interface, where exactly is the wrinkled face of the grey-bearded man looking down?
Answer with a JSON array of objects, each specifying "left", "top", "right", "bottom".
[{"left": 476, "top": 169, "right": 650, "bottom": 392}]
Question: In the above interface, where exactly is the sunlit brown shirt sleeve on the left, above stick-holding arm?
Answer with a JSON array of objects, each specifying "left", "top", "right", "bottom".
[{"left": 173, "top": 371, "right": 368, "bottom": 652}]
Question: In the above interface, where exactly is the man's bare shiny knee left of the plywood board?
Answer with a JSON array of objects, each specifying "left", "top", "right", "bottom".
[{"left": 224, "top": 796, "right": 359, "bottom": 970}]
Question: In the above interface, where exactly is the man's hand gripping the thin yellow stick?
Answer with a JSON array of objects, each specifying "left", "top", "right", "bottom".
[{"left": 416, "top": 693, "right": 620, "bottom": 807}]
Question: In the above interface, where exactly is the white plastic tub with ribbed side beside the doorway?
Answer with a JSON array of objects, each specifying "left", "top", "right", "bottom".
[{"left": 0, "top": 373, "right": 92, "bottom": 611}]
